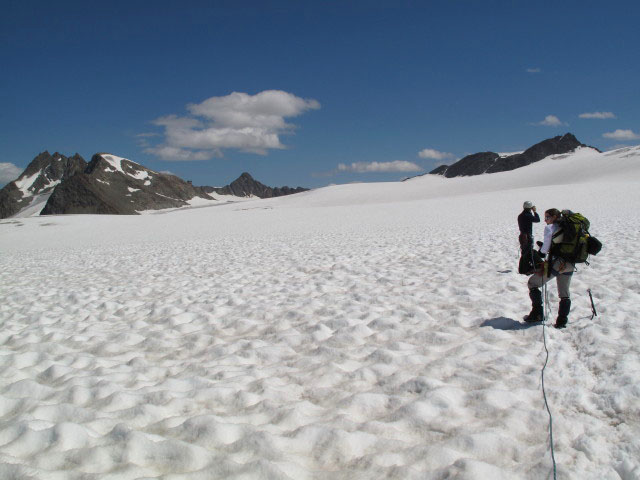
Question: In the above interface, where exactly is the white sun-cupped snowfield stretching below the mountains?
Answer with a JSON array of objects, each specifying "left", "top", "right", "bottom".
[{"left": 0, "top": 148, "right": 640, "bottom": 480}]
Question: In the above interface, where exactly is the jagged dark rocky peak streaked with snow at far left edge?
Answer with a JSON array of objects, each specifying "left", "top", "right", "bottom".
[{"left": 0, "top": 151, "right": 87, "bottom": 218}]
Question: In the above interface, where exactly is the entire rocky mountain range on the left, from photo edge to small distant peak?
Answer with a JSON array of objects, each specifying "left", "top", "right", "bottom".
[{"left": 0, "top": 152, "right": 307, "bottom": 218}]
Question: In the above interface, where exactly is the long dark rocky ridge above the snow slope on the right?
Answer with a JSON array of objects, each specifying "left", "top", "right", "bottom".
[{"left": 429, "top": 133, "right": 586, "bottom": 178}]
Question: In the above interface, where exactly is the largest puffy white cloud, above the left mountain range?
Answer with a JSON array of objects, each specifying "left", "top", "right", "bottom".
[{"left": 145, "top": 90, "right": 320, "bottom": 160}]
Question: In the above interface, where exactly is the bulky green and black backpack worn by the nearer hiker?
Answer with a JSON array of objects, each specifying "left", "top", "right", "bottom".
[{"left": 551, "top": 211, "right": 602, "bottom": 264}]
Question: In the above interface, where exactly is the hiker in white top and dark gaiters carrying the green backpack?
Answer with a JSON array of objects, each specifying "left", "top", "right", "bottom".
[{"left": 525, "top": 208, "right": 575, "bottom": 328}]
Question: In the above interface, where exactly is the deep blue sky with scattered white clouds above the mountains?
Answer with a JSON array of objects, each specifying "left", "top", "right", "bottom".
[{"left": 0, "top": 0, "right": 640, "bottom": 187}]
